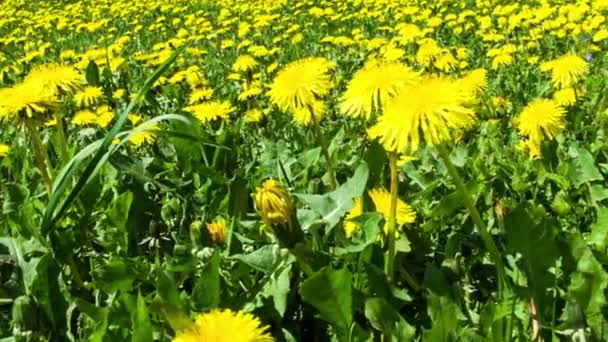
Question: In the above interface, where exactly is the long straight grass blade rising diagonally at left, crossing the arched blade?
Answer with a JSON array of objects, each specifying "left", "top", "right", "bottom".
[{"left": 41, "top": 44, "right": 187, "bottom": 236}]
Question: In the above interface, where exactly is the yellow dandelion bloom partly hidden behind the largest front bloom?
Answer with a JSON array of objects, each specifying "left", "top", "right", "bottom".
[{"left": 340, "top": 61, "right": 419, "bottom": 119}]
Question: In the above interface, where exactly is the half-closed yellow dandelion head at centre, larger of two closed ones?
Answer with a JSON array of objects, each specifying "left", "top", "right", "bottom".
[{"left": 253, "top": 179, "right": 295, "bottom": 227}]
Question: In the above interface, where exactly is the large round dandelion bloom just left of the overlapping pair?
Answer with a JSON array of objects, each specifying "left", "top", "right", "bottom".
[{"left": 268, "top": 57, "right": 335, "bottom": 112}]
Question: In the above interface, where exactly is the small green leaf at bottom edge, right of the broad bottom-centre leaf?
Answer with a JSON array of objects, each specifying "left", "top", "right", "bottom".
[{"left": 365, "top": 298, "right": 416, "bottom": 341}]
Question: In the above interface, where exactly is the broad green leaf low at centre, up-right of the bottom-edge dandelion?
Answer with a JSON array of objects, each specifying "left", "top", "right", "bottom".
[{"left": 300, "top": 267, "right": 353, "bottom": 335}]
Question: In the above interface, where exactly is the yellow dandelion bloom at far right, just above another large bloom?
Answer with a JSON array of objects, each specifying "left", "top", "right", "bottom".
[{"left": 540, "top": 53, "right": 589, "bottom": 89}]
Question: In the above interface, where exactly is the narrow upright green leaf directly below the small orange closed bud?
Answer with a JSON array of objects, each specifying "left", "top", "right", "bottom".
[{"left": 192, "top": 250, "right": 220, "bottom": 311}]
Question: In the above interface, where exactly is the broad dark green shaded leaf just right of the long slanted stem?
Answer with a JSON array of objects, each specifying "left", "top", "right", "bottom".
[{"left": 505, "top": 204, "right": 558, "bottom": 321}]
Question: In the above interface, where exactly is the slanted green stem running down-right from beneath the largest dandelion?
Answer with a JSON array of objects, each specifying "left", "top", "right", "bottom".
[{"left": 436, "top": 145, "right": 505, "bottom": 294}]
